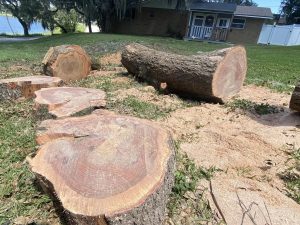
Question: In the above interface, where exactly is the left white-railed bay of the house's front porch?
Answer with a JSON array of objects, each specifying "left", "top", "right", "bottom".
[{"left": 190, "top": 14, "right": 215, "bottom": 39}]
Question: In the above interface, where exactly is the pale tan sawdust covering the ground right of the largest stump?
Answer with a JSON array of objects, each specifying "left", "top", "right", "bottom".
[{"left": 162, "top": 86, "right": 300, "bottom": 185}]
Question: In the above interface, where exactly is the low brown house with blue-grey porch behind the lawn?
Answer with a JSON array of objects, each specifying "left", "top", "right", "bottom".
[{"left": 112, "top": 0, "right": 273, "bottom": 43}]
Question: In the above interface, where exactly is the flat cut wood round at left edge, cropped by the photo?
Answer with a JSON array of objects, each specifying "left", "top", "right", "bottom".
[{"left": 0, "top": 76, "right": 63, "bottom": 100}]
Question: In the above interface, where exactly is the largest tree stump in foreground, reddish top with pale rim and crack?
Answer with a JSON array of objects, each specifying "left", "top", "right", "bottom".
[{"left": 29, "top": 110, "right": 175, "bottom": 225}]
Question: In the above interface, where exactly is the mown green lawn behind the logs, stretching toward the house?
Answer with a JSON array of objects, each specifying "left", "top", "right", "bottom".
[{"left": 0, "top": 34, "right": 300, "bottom": 92}]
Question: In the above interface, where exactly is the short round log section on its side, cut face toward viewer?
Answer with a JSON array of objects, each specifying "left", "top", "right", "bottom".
[{"left": 42, "top": 45, "right": 91, "bottom": 81}]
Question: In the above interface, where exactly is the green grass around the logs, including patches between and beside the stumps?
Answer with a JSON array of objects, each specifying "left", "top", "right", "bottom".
[{"left": 0, "top": 34, "right": 300, "bottom": 225}]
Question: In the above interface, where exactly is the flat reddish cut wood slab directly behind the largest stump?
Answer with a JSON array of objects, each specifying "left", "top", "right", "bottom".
[{"left": 34, "top": 87, "right": 106, "bottom": 119}]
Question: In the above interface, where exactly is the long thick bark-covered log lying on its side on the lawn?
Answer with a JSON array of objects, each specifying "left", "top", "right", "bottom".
[{"left": 122, "top": 44, "right": 247, "bottom": 102}]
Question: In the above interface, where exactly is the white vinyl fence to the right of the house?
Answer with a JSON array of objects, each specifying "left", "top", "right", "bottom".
[{"left": 258, "top": 24, "right": 300, "bottom": 46}]
